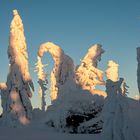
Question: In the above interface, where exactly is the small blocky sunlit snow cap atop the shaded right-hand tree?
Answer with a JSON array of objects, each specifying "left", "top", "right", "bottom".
[{"left": 106, "top": 60, "right": 119, "bottom": 82}]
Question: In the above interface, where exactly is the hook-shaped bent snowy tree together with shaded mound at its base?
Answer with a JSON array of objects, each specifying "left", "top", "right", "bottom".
[{"left": 38, "top": 42, "right": 104, "bottom": 133}]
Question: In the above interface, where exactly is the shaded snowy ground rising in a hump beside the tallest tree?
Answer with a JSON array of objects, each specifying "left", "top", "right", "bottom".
[{"left": 0, "top": 108, "right": 101, "bottom": 140}]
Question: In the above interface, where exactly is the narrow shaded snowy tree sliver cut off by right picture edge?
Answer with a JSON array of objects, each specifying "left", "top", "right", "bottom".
[{"left": 137, "top": 47, "right": 140, "bottom": 93}]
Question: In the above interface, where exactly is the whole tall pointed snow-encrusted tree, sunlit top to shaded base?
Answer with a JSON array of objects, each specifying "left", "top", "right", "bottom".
[{"left": 2, "top": 10, "right": 34, "bottom": 127}]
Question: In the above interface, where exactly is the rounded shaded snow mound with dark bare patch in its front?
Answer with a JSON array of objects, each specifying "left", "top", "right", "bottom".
[{"left": 46, "top": 88, "right": 104, "bottom": 133}]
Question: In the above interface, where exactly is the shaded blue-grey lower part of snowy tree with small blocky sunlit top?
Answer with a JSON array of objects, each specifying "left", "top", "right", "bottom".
[{"left": 103, "top": 78, "right": 123, "bottom": 140}]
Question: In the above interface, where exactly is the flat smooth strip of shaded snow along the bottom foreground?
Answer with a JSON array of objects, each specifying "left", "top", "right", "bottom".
[{"left": 0, "top": 128, "right": 101, "bottom": 140}]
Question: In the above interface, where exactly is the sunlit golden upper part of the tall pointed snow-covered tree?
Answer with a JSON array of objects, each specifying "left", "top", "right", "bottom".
[{"left": 8, "top": 10, "right": 34, "bottom": 90}]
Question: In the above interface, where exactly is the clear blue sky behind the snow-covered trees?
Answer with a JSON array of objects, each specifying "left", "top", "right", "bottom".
[{"left": 0, "top": 0, "right": 140, "bottom": 109}]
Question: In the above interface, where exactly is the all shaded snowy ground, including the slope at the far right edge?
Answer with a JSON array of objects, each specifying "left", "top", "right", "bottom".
[{"left": 0, "top": 98, "right": 140, "bottom": 140}]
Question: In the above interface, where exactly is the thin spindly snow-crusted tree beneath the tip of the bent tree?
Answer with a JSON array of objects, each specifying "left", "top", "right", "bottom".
[{"left": 35, "top": 56, "right": 48, "bottom": 111}]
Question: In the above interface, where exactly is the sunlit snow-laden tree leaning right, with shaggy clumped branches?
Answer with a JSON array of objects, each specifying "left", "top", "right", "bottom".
[{"left": 76, "top": 44, "right": 106, "bottom": 96}]
